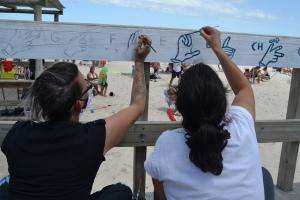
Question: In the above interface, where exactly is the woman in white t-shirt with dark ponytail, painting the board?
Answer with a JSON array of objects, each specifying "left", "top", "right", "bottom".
[{"left": 145, "top": 27, "right": 268, "bottom": 200}]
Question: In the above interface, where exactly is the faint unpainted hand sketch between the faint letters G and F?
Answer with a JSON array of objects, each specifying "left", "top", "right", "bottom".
[{"left": 64, "top": 33, "right": 88, "bottom": 58}]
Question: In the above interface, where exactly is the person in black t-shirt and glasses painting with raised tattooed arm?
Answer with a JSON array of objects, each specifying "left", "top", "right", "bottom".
[{"left": 1, "top": 36, "right": 151, "bottom": 200}]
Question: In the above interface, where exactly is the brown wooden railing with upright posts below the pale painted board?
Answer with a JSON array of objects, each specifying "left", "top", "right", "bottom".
[{"left": 0, "top": 67, "right": 300, "bottom": 196}]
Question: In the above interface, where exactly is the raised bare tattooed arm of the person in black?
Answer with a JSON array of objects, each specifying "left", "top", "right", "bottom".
[{"left": 104, "top": 36, "right": 151, "bottom": 154}]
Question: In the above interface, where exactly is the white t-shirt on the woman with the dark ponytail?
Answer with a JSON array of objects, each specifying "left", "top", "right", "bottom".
[{"left": 145, "top": 106, "right": 264, "bottom": 200}]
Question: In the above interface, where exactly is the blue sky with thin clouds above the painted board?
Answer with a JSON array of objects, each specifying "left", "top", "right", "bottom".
[{"left": 0, "top": 0, "right": 300, "bottom": 37}]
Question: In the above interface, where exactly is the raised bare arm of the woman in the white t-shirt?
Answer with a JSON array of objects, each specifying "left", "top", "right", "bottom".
[{"left": 201, "top": 27, "right": 255, "bottom": 120}]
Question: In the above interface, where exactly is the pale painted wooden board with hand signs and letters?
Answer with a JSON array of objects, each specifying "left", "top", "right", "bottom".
[{"left": 0, "top": 20, "right": 300, "bottom": 67}]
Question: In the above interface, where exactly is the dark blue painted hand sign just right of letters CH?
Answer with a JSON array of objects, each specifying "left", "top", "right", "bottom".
[{"left": 259, "top": 38, "right": 284, "bottom": 67}]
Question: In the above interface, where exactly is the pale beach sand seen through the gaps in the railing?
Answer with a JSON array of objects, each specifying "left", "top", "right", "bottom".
[{"left": 0, "top": 62, "right": 300, "bottom": 199}]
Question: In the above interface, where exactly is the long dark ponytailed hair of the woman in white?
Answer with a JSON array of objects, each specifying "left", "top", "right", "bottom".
[{"left": 176, "top": 63, "right": 230, "bottom": 175}]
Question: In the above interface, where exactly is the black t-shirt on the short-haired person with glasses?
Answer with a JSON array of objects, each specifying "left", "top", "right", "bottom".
[{"left": 1, "top": 120, "right": 106, "bottom": 200}]
